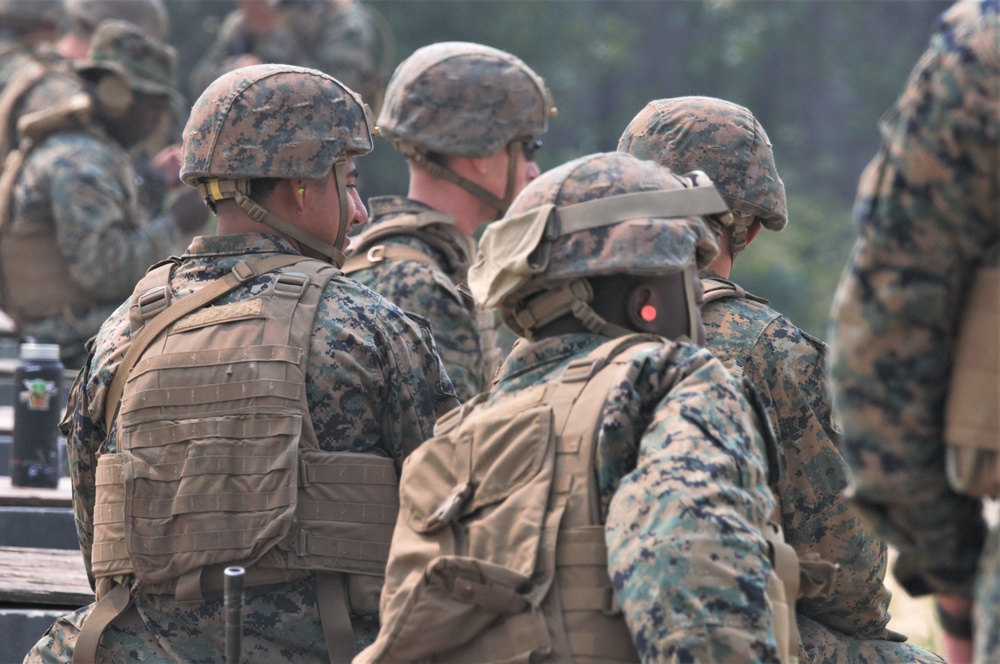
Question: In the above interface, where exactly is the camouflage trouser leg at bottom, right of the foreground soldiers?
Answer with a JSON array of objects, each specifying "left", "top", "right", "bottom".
[{"left": 797, "top": 614, "right": 944, "bottom": 664}]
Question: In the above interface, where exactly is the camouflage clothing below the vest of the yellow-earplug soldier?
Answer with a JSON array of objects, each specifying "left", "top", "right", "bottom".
[{"left": 24, "top": 582, "right": 378, "bottom": 664}]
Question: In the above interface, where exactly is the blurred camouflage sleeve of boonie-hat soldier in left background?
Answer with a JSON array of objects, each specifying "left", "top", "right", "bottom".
[{"left": 38, "top": 137, "right": 180, "bottom": 302}]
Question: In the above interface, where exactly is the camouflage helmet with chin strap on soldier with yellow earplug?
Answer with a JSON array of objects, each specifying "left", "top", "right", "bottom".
[{"left": 181, "top": 65, "right": 372, "bottom": 267}]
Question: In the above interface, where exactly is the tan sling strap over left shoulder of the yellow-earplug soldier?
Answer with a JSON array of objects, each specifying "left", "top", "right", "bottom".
[{"left": 104, "top": 254, "right": 308, "bottom": 434}]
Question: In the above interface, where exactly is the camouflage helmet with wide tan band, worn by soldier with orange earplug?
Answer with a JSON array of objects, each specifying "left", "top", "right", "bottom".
[{"left": 469, "top": 152, "right": 729, "bottom": 339}]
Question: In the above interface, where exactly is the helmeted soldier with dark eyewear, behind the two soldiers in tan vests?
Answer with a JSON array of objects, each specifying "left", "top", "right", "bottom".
[{"left": 345, "top": 42, "right": 554, "bottom": 400}]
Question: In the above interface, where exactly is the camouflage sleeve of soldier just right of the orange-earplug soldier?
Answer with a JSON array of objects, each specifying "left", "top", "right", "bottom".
[{"left": 743, "top": 317, "right": 889, "bottom": 638}]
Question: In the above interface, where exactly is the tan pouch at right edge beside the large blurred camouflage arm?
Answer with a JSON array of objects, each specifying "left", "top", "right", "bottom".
[{"left": 944, "top": 249, "right": 1000, "bottom": 498}]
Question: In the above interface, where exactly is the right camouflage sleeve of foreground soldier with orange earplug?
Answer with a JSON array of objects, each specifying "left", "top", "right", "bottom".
[{"left": 606, "top": 344, "right": 777, "bottom": 662}]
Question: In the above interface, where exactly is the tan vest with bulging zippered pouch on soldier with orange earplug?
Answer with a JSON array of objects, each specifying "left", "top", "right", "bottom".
[{"left": 355, "top": 335, "right": 798, "bottom": 664}]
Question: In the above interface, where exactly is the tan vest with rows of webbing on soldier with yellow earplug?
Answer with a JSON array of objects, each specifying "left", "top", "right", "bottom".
[{"left": 74, "top": 256, "right": 399, "bottom": 661}]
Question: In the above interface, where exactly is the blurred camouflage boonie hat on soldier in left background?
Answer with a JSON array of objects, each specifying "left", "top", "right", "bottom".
[{"left": 76, "top": 21, "right": 177, "bottom": 96}]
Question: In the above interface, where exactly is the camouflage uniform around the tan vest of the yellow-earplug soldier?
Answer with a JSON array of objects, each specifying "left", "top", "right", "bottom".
[{"left": 26, "top": 235, "right": 456, "bottom": 662}]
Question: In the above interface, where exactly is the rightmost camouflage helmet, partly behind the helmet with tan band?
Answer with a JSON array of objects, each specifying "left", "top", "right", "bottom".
[{"left": 618, "top": 97, "right": 788, "bottom": 258}]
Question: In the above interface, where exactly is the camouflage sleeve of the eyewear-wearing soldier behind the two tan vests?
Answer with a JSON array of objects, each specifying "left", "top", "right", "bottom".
[{"left": 364, "top": 261, "right": 484, "bottom": 401}]
